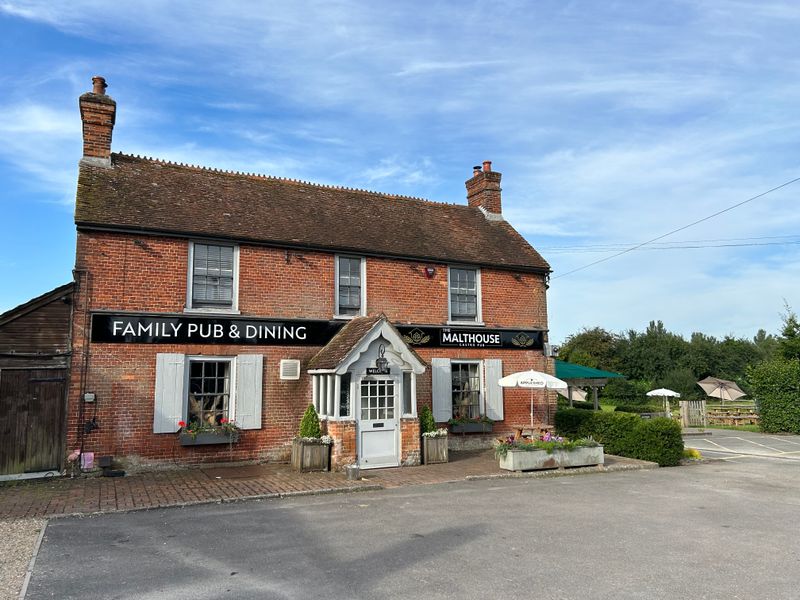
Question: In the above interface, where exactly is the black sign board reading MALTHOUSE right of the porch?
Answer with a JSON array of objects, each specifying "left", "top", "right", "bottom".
[{"left": 397, "top": 325, "right": 544, "bottom": 350}]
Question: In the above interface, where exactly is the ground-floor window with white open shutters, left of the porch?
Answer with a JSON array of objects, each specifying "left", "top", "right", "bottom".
[{"left": 153, "top": 353, "right": 264, "bottom": 433}]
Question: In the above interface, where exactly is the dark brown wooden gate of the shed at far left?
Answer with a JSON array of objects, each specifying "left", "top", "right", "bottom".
[{"left": 0, "top": 369, "right": 67, "bottom": 475}]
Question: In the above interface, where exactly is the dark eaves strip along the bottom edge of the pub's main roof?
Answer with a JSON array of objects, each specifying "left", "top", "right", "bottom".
[{"left": 75, "top": 220, "right": 552, "bottom": 275}]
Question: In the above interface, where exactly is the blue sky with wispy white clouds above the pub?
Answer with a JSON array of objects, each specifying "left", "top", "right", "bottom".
[{"left": 0, "top": 0, "right": 800, "bottom": 341}]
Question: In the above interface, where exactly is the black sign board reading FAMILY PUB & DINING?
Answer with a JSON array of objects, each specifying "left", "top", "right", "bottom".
[{"left": 92, "top": 313, "right": 344, "bottom": 346}]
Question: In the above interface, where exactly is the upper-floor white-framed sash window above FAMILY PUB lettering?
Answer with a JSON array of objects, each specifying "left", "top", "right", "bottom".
[{"left": 186, "top": 242, "right": 239, "bottom": 312}]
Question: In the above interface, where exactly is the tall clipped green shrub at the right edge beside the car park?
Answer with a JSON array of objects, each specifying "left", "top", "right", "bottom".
[{"left": 747, "top": 359, "right": 800, "bottom": 434}]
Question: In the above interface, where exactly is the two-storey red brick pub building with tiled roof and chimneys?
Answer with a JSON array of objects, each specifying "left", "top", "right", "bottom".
[{"left": 67, "top": 77, "right": 555, "bottom": 468}]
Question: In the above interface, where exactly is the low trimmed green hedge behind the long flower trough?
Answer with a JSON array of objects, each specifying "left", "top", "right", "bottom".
[{"left": 555, "top": 409, "right": 683, "bottom": 467}]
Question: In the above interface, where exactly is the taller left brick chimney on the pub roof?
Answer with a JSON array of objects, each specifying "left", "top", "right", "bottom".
[{"left": 78, "top": 76, "right": 117, "bottom": 167}]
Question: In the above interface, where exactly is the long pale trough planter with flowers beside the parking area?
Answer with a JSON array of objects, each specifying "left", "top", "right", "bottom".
[{"left": 495, "top": 433, "right": 603, "bottom": 471}]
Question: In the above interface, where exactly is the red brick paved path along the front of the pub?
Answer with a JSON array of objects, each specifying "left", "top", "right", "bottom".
[{"left": 0, "top": 450, "right": 653, "bottom": 519}]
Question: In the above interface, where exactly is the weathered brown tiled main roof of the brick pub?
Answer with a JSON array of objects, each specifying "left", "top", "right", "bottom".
[{"left": 75, "top": 154, "right": 549, "bottom": 271}]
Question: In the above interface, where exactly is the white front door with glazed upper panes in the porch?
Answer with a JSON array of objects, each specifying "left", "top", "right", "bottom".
[{"left": 358, "top": 377, "right": 400, "bottom": 469}]
